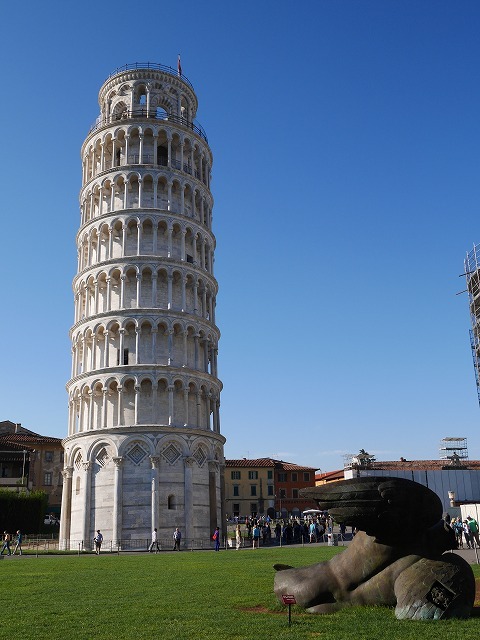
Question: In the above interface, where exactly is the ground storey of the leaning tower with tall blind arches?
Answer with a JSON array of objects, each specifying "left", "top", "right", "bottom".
[{"left": 64, "top": 429, "right": 224, "bottom": 548}]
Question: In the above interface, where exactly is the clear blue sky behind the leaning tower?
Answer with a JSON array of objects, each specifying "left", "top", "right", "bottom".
[{"left": 0, "top": 0, "right": 480, "bottom": 471}]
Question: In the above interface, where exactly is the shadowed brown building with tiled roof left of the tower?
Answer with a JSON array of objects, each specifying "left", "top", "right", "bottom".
[{"left": 0, "top": 420, "right": 64, "bottom": 514}]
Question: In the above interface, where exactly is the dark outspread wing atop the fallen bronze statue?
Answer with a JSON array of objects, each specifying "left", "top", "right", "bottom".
[{"left": 301, "top": 476, "right": 442, "bottom": 540}]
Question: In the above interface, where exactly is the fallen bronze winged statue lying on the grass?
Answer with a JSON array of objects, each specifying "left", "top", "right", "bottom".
[{"left": 274, "top": 477, "right": 475, "bottom": 620}]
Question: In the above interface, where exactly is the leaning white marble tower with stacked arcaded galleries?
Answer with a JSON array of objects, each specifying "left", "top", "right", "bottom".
[{"left": 60, "top": 63, "right": 225, "bottom": 548}]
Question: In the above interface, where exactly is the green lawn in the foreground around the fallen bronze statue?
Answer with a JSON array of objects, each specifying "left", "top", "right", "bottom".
[{"left": 0, "top": 547, "right": 480, "bottom": 640}]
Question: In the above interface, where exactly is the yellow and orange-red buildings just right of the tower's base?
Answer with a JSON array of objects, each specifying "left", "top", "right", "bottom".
[{"left": 225, "top": 458, "right": 316, "bottom": 518}]
